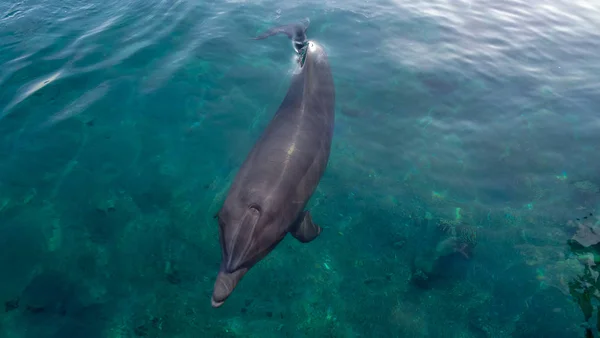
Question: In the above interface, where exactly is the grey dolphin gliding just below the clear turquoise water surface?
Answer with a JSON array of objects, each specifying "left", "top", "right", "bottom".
[{"left": 211, "top": 19, "right": 335, "bottom": 307}]
